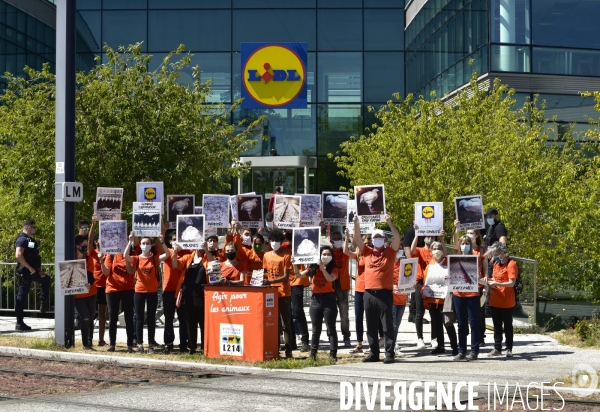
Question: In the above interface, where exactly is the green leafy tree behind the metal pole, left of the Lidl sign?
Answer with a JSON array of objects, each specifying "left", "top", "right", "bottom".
[{"left": 0, "top": 43, "right": 261, "bottom": 262}]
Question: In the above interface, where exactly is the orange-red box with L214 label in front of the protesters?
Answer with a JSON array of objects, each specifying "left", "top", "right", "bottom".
[{"left": 204, "top": 285, "right": 279, "bottom": 362}]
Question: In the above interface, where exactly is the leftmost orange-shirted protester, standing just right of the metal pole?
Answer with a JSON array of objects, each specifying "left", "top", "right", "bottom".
[{"left": 75, "top": 233, "right": 96, "bottom": 350}]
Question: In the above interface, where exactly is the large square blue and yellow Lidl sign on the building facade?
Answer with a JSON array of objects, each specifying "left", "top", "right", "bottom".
[{"left": 241, "top": 43, "right": 308, "bottom": 109}]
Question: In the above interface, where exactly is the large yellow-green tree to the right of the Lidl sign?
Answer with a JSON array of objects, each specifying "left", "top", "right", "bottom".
[{"left": 335, "top": 80, "right": 600, "bottom": 297}]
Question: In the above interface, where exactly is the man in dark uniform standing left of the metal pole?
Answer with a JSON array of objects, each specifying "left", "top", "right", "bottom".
[{"left": 15, "top": 220, "right": 50, "bottom": 330}]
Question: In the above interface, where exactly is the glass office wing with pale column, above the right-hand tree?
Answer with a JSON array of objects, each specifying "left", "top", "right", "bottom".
[{"left": 405, "top": 0, "right": 600, "bottom": 135}]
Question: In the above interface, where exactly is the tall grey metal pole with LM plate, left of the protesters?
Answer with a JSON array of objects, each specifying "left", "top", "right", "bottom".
[{"left": 54, "top": 0, "right": 77, "bottom": 347}]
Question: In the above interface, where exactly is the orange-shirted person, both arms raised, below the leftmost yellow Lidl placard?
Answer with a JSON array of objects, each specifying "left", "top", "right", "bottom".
[{"left": 123, "top": 232, "right": 170, "bottom": 353}]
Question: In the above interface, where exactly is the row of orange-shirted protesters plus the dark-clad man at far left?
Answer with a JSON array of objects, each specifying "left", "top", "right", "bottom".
[{"left": 15, "top": 201, "right": 518, "bottom": 363}]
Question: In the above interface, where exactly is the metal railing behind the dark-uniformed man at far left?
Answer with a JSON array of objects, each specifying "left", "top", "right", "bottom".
[{"left": 0, "top": 262, "right": 54, "bottom": 313}]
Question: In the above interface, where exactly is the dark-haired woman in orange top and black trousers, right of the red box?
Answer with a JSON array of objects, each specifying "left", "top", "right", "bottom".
[{"left": 292, "top": 246, "right": 338, "bottom": 362}]
